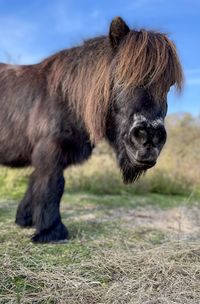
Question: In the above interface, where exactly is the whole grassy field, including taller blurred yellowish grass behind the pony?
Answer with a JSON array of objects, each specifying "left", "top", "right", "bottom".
[{"left": 0, "top": 115, "right": 200, "bottom": 304}]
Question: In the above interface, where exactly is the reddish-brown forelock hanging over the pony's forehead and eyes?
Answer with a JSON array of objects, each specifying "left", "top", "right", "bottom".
[{"left": 113, "top": 30, "right": 183, "bottom": 101}]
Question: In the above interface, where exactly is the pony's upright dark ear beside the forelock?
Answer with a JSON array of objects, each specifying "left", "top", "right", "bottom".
[{"left": 109, "top": 17, "right": 130, "bottom": 48}]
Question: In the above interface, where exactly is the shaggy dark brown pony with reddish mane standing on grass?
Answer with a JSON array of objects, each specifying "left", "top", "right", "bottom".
[{"left": 0, "top": 17, "right": 182, "bottom": 242}]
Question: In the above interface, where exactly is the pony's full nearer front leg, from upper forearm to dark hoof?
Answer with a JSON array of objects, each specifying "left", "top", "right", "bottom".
[{"left": 29, "top": 141, "right": 68, "bottom": 243}]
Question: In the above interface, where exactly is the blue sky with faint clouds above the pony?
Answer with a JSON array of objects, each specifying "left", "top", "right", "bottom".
[{"left": 0, "top": 0, "right": 200, "bottom": 115}]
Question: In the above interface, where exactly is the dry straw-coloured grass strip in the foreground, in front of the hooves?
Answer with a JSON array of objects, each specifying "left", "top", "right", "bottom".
[{"left": 0, "top": 235, "right": 200, "bottom": 304}]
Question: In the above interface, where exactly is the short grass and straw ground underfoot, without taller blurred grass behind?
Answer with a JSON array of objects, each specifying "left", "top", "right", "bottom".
[{"left": 0, "top": 193, "right": 200, "bottom": 304}]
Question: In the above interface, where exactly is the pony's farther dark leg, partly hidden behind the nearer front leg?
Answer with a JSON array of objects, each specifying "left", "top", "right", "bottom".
[{"left": 15, "top": 174, "right": 34, "bottom": 227}]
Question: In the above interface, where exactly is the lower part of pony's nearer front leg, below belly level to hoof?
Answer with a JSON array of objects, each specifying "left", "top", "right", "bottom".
[{"left": 32, "top": 171, "right": 68, "bottom": 243}]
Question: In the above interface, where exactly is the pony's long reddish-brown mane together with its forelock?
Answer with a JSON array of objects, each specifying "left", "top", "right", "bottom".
[{"left": 43, "top": 30, "right": 183, "bottom": 142}]
